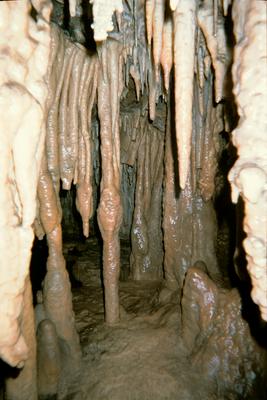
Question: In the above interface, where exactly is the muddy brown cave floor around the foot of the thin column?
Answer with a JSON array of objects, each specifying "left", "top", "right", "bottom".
[{"left": 65, "top": 239, "right": 218, "bottom": 400}]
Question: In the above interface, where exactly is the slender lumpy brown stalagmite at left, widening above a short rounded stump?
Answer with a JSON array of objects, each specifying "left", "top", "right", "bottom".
[{"left": 38, "top": 153, "right": 81, "bottom": 396}]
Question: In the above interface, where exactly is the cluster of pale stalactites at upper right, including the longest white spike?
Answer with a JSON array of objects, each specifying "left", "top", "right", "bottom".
[{"left": 146, "top": 0, "right": 229, "bottom": 189}]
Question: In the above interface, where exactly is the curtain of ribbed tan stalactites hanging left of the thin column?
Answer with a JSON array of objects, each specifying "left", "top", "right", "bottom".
[{"left": 35, "top": 25, "right": 98, "bottom": 237}]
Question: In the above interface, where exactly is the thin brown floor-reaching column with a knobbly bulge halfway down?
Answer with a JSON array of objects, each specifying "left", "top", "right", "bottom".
[{"left": 97, "top": 40, "right": 122, "bottom": 324}]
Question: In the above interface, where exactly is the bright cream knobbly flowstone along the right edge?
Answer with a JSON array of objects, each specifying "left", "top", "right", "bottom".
[{"left": 229, "top": 0, "right": 267, "bottom": 321}]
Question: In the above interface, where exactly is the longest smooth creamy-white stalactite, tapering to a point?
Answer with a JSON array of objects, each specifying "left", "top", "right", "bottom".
[{"left": 173, "top": 0, "right": 197, "bottom": 189}]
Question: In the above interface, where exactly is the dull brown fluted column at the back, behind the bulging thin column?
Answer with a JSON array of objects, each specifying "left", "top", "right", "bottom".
[{"left": 129, "top": 115, "right": 164, "bottom": 280}]
